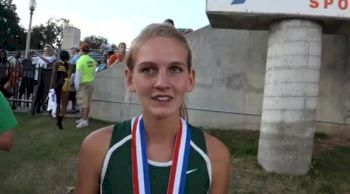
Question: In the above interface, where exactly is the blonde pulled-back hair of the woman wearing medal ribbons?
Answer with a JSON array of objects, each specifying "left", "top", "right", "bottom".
[{"left": 126, "top": 24, "right": 192, "bottom": 120}]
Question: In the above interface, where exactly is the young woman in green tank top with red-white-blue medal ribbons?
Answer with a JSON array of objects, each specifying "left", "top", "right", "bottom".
[{"left": 76, "top": 24, "right": 231, "bottom": 194}]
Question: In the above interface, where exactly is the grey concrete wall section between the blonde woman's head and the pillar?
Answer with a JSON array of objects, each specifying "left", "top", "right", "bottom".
[{"left": 188, "top": 27, "right": 268, "bottom": 129}]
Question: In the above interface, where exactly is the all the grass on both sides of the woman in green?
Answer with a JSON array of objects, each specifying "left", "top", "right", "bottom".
[{"left": 0, "top": 113, "right": 350, "bottom": 194}]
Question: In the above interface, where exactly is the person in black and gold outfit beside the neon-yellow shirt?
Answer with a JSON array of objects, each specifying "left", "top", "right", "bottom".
[{"left": 50, "top": 50, "right": 72, "bottom": 129}]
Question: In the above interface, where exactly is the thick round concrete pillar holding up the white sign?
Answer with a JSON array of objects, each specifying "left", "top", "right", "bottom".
[{"left": 258, "top": 20, "right": 322, "bottom": 174}]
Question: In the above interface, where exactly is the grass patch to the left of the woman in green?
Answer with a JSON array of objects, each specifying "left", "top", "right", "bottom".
[{"left": 0, "top": 113, "right": 108, "bottom": 194}]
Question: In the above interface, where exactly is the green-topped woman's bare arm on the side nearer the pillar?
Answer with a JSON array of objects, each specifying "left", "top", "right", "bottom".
[{"left": 205, "top": 134, "right": 232, "bottom": 194}]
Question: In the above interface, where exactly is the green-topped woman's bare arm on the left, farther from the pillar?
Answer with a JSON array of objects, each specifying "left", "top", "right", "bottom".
[{"left": 76, "top": 126, "right": 113, "bottom": 194}]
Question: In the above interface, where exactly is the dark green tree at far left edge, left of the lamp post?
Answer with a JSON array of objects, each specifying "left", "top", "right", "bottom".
[{"left": 0, "top": 0, "right": 26, "bottom": 50}]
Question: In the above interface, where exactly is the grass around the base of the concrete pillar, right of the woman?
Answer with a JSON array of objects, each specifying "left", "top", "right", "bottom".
[{"left": 209, "top": 130, "right": 350, "bottom": 194}]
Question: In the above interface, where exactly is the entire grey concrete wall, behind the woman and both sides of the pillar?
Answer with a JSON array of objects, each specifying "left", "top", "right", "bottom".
[{"left": 91, "top": 27, "right": 350, "bottom": 135}]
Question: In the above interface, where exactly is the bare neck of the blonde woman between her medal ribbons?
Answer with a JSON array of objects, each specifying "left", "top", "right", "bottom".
[{"left": 143, "top": 114, "right": 180, "bottom": 143}]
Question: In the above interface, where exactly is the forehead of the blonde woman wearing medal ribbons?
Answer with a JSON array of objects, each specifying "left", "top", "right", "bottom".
[{"left": 135, "top": 37, "right": 188, "bottom": 64}]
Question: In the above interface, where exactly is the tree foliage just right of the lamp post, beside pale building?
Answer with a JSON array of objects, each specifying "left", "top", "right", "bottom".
[{"left": 31, "top": 18, "right": 71, "bottom": 49}]
